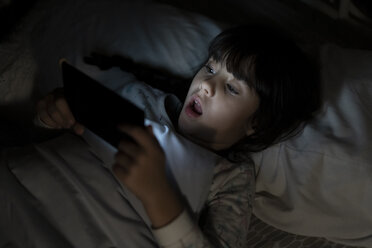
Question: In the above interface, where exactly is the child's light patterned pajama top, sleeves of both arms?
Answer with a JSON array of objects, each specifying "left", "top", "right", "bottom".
[{"left": 34, "top": 65, "right": 254, "bottom": 247}]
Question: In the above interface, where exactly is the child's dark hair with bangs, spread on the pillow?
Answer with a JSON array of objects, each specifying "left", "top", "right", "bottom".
[{"left": 209, "top": 26, "right": 320, "bottom": 152}]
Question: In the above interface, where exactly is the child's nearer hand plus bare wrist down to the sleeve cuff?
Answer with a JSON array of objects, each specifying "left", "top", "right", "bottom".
[{"left": 113, "top": 125, "right": 183, "bottom": 228}]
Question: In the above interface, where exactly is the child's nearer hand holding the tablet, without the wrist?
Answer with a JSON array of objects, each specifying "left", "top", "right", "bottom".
[{"left": 113, "top": 125, "right": 168, "bottom": 201}]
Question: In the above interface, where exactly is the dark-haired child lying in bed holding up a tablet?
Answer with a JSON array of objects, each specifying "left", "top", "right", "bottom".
[{"left": 13, "top": 26, "right": 319, "bottom": 247}]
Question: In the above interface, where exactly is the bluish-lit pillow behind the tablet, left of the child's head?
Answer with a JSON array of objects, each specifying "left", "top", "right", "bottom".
[{"left": 32, "top": 0, "right": 220, "bottom": 93}]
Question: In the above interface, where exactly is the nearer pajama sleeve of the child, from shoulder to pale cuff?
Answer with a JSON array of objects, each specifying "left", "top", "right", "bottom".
[{"left": 152, "top": 160, "right": 254, "bottom": 248}]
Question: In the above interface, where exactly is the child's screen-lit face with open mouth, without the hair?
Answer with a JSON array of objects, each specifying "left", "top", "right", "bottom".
[{"left": 178, "top": 59, "right": 259, "bottom": 151}]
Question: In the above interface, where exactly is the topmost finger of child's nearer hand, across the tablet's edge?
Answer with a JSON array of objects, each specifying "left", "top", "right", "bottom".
[{"left": 119, "top": 125, "right": 159, "bottom": 150}]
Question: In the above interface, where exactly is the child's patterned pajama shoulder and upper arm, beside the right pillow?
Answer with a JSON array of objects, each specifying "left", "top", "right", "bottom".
[{"left": 199, "top": 160, "right": 255, "bottom": 247}]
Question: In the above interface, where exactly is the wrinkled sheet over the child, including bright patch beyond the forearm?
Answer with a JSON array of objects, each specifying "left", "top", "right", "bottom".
[{"left": 0, "top": 119, "right": 218, "bottom": 248}]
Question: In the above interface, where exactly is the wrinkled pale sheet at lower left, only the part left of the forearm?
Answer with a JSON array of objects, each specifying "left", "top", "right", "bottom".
[{"left": 0, "top": 134, "right": 156, "bottom": 247}]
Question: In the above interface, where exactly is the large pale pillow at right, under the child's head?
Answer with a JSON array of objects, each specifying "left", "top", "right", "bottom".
[{"left": 254, "top": 44, "right": 372, "bottom": 247}]
